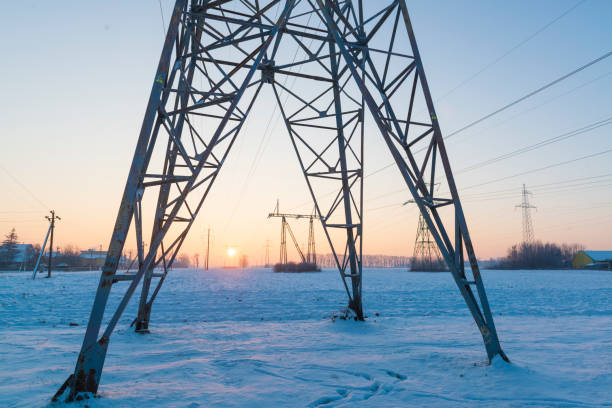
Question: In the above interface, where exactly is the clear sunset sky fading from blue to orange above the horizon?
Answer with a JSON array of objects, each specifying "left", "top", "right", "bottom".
[{"left": 0, "top": 0, "right": 612, "bottom": 265}]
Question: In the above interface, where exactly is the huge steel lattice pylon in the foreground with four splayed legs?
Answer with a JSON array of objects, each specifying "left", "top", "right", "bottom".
[{"left": 57, "top": 0, "right": 505, "bottom": 400}]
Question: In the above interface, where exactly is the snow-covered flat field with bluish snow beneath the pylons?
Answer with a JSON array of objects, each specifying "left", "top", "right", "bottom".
[{"left": 0, "top": 269, "right": 612, "bottom": 407}]
